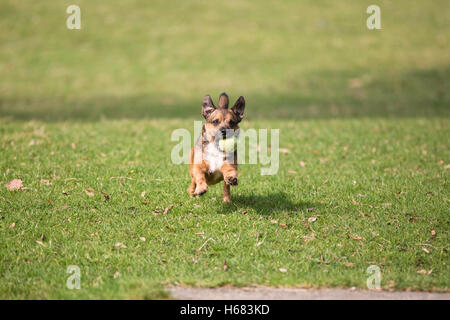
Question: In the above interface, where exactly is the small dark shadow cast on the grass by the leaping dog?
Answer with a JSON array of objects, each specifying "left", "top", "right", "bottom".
[{"left": 223, "top": 192, "right": 318, "bottom": 215}]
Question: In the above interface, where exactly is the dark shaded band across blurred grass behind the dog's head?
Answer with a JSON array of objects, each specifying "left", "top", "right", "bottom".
[{"left": 0, "top": 67, "right": 450, "bottom": 122}]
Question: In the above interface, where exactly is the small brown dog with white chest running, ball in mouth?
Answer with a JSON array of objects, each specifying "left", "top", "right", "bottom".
[{"left": 188, "top": 92, "right": 245, "bottom": 203}]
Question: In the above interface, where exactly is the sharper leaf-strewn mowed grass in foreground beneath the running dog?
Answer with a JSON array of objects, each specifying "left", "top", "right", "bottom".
[{"left": 1, "top": 119, "right": 449, "bottom": 298}]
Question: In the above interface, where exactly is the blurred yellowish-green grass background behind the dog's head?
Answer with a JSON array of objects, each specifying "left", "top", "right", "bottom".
[{"left": 0, "top": 0, "right": 450, "bottom": 121}]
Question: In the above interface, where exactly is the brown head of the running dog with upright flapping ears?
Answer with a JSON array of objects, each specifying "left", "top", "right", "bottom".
[{"left": 202, "top": 92, "right": 245, "bottom": 138}]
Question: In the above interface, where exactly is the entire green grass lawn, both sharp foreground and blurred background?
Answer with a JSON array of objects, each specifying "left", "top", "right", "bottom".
[{"left": 0, "top": 1, "right": 450, "bottom": 299}]
